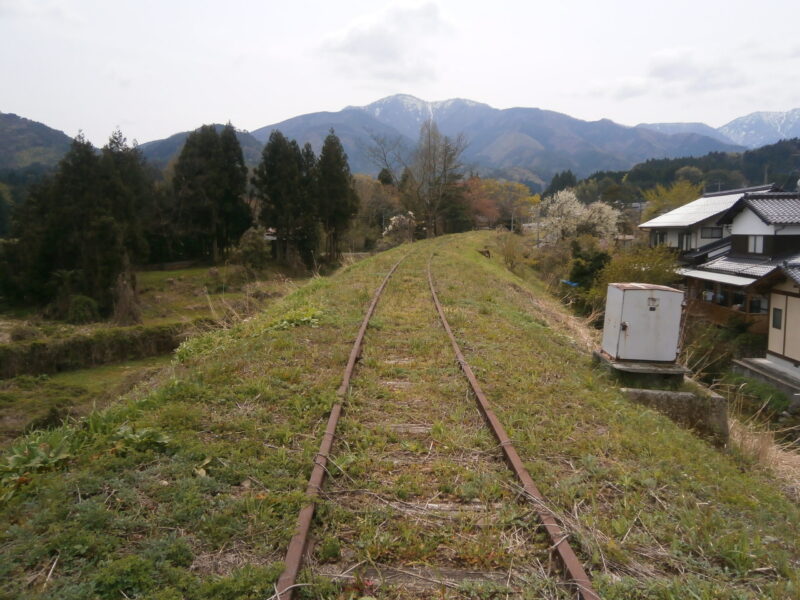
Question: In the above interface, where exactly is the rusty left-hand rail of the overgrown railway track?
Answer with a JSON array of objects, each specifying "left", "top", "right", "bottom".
[{"left": 275, "top": 255, "right": 407, "bottom": 600}]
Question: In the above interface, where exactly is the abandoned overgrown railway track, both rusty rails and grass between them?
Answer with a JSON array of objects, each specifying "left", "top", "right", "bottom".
[{"left": 276, "top": 250, "right": 599, "bottom": 600}]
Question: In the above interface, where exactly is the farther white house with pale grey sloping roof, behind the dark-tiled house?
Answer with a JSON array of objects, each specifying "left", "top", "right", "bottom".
[{"left": 639, "top": 184, "right": 775, "bottom": 253}]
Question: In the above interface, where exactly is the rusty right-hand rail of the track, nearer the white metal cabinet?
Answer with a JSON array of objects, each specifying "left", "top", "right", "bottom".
[{"left": 428, "top": 255, "right": 600, "bottom": 600}]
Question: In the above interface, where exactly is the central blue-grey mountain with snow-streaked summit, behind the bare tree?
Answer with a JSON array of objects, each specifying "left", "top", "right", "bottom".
[{"left": 253, "top": 94, "right": 742, "bottom": 184}]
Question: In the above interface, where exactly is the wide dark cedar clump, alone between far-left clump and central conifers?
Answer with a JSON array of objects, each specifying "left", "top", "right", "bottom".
[{"left": 172, "top": 123, "right": 251, "bottom": 263}]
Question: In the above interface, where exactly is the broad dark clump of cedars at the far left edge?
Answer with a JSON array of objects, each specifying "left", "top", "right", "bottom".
[{"left": 0, "top": 132, "right": 153, "bottom": 314}]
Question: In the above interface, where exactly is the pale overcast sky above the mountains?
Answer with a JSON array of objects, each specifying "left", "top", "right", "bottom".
[{"left": 0, "top": 0, "right": 800, "bottom": 145}]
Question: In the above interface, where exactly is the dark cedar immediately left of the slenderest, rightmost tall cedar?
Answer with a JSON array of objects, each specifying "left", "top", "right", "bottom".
[{"left": 252, "top": 130, "right": 319, "bottom": 267}]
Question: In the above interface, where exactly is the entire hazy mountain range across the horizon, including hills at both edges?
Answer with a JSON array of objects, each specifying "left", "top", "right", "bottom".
[{"left": 0, "top": 94, "right": 800, "bottom": 185}]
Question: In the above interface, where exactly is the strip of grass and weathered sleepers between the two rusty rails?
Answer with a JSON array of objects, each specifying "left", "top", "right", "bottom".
[{"left": 302, "top": 247, "right": 571, "bottom": 600}]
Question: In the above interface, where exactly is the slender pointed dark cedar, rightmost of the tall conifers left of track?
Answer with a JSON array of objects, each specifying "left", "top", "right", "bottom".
[{"left": 316, "top": 129, "right": 358, "bottom": 262}]
